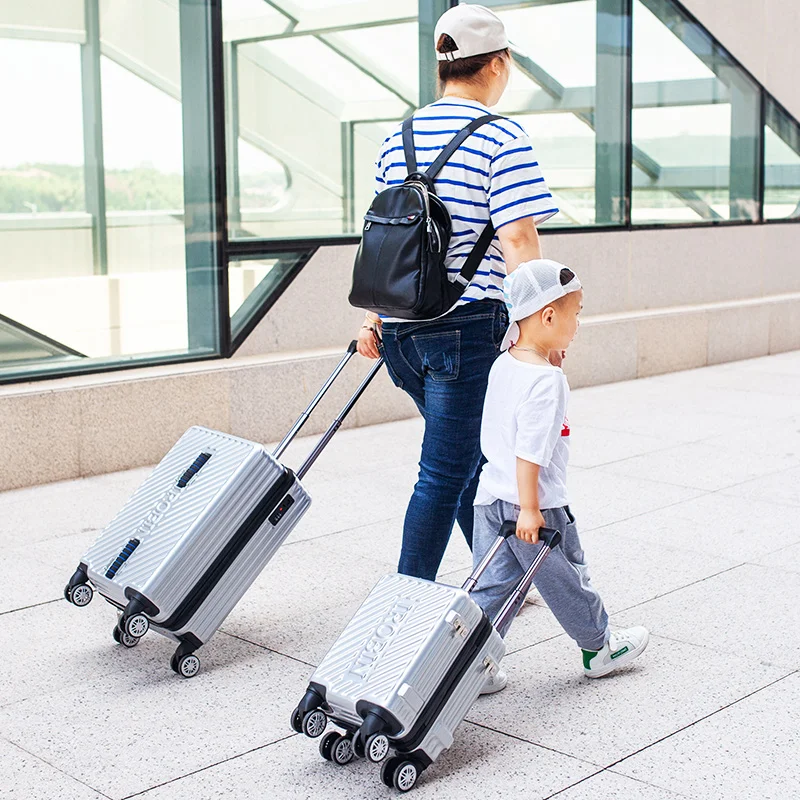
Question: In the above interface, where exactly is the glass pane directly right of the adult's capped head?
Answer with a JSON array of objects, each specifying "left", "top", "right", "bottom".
[{"left": 466, "top": 0, "right": 630, "bottom": 227}]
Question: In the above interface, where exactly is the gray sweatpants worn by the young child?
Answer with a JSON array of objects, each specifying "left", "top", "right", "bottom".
[{"left": 472, "top": 500, "right": 609, "bottom": 650}]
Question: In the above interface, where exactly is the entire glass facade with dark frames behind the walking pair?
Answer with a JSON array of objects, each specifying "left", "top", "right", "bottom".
[{"left": 0, "top": 0, "right": 800, "bottom": 382}]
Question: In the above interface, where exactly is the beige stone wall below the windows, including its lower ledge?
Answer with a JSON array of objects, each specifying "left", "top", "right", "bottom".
[{"left": 0, "top": 224, "right": 800, "bottom": 489}]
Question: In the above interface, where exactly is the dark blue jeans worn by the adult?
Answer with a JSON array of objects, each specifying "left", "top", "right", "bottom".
[{"left": 380, "top": 300, "right": 508, "bottom": 580}]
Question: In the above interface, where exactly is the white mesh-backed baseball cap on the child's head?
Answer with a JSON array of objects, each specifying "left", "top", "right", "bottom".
[{"left": 500, "top": 258, "right": 583, "bottom": 350}]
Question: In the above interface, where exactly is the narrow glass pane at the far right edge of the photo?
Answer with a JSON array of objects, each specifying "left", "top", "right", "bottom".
[{"left": 764, "top": 98, "right": 800, "bottom": 219}]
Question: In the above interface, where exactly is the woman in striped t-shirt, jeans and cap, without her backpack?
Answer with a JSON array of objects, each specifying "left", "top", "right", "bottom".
[{"left": 358, "top": 5, "right": 558, "bottom": 580}]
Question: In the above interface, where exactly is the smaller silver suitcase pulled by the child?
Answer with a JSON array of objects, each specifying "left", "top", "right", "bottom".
[{"left": 291, "top": 522, "right": 561, "bottom": 791}]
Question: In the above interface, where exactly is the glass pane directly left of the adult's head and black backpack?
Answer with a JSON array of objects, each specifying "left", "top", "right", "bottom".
[{"left": 222, "top": 0, "right": 419, "bottom": 247}]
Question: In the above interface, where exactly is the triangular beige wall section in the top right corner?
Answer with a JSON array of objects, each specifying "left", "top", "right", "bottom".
[{"left": 682, "top": 0, "right": 800, "bottom": 119}]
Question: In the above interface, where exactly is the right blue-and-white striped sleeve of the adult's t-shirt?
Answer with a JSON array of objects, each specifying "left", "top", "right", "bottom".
[{"left": 489, "top": 135, "right": 558, "bottom": 229}]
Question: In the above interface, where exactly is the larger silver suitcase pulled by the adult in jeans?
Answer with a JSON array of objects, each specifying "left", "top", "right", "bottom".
[{"left": 64, "top": 342, "right": 382, "bottom": 678}]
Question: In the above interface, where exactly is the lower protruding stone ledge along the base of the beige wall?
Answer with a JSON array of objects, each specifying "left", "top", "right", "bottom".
[{"left": 0, "top": 293, "right": 800, "bottom": 490}]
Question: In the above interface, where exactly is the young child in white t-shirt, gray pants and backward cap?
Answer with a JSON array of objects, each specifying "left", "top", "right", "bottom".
[{"left": 472, "top": 259, "right": 649, "bottom": 694}]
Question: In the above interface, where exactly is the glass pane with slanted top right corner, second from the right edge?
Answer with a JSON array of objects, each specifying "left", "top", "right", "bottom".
[{"left": 631, "top": 0, "right": 760, "bottom": 224}]
